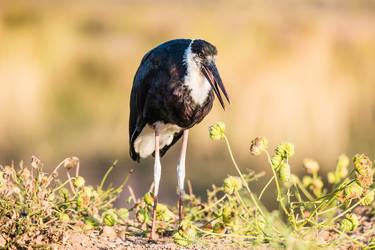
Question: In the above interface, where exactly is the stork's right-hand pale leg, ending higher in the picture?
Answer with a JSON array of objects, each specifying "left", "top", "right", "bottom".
[{"left": 177, "top": 129, "right": 189, "bottom": 223}]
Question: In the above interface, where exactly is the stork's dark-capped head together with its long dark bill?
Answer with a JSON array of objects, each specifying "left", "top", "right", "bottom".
[{"left": 191, "top": 39, "right": 230, "bottom": 108}]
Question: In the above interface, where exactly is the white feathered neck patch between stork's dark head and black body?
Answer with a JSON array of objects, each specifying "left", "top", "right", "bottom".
[{"left": 184, "top": 40, "right": 211, "bottom": 105}]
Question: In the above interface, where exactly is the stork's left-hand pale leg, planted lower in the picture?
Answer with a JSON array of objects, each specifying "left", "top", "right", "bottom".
[{"left": 150, "top": 125, "right": 161, "bottom": 240}]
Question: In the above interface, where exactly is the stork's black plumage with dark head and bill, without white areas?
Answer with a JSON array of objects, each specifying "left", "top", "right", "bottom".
[{"left": 129, "top": 39, "right": 229, "bottom": 161}]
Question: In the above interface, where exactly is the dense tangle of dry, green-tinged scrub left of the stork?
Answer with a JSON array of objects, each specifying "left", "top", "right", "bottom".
[{"left": 0, "top": 157, "right": 128, "bottom": 249}]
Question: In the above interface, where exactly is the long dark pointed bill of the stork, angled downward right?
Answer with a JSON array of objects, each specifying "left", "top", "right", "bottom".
[{"left": 202, "top": 63, "right": 230, "bottom": 109}]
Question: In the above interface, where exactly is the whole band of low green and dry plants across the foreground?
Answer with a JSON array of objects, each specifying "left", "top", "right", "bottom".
[{"left": 0, "top": 123, "right": 375, "bottom": 249}]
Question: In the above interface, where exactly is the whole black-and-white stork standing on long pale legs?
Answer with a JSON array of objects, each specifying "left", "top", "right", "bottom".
[{"left": 129, "top": 39, "right": 230, "bottom": 240}]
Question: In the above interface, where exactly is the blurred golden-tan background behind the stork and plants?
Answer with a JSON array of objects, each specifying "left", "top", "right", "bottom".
[{"left": 0, "top": 0, "right": 375, "bottom": 207}]
